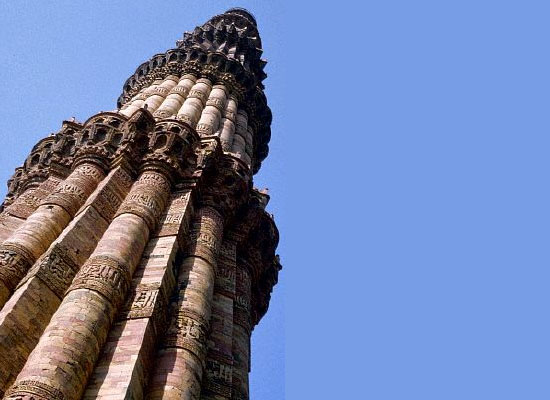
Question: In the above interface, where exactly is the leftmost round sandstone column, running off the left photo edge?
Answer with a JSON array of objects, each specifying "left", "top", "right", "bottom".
[{"left": 0, "top": 162, "right": 105, "bottom": 307}]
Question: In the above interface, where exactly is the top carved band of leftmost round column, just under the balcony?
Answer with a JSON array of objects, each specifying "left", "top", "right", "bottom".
[{"left": 42, "top": 164, "right": 105, "bottom": 216}]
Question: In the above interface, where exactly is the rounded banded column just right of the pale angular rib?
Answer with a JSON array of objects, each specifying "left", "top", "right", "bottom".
[{"left": 146, "top": 206, "right": 223, "bottom": 400}]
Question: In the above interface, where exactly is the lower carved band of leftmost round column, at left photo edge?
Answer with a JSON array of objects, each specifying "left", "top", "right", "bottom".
[{"left": 0, "top": 243, "right": 35, "bottom": 292}]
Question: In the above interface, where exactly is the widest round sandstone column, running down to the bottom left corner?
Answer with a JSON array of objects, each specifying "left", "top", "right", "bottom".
[{"left": 6, "top": 169, "right": 170, "bottom": 400}]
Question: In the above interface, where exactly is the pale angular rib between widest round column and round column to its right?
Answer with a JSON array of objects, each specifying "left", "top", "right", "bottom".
[{"left": 83, "top": 189, "right": 193, "bottom": 400}]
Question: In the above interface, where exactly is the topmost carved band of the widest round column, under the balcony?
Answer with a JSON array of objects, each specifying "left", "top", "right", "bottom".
[{"left": 116, "top": 171, "right": 170, "bottom": 231}]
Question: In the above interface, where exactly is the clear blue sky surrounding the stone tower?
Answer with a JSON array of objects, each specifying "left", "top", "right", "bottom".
[{"left": 0, "top": 0, "right": 550, "bottom": 400}]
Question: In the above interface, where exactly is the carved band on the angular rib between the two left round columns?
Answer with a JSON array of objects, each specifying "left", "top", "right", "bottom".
[{"left": 17, "top": 246, "right": 78, "bottom": 299}]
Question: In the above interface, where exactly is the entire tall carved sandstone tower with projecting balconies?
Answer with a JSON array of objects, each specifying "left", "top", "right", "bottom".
[{"left": 0, "top": 9, "right": 281, "bottom": 400}]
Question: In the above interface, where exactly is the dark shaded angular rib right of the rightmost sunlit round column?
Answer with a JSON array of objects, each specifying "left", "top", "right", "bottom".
[{"left": 200, "top": 237, "right": 237, "bottom": 400}]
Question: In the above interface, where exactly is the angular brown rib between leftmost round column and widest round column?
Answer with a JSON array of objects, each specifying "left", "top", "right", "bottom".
[{"left": 0, "top": 166, "right": 132, "bottom": 395}]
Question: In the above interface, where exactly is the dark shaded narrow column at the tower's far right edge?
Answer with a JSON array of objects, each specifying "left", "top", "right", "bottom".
[{"left": 232, "top": 258, "right": 252, "bottom": 400}]
